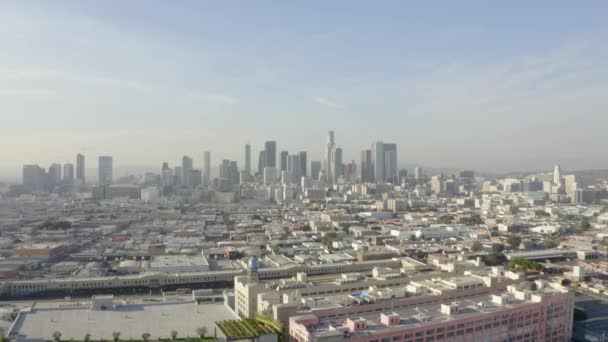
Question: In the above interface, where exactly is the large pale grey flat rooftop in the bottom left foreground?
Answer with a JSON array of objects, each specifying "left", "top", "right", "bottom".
[{"left": 13, "top": 301, "right": 238, "bottom": 341}]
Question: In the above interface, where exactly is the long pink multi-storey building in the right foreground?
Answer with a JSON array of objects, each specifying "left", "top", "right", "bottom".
[{"left": 289, "top": 286, "right": 574, "bottom": 342}]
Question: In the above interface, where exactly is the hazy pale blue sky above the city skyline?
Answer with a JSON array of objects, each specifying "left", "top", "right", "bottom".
[{"left": 0, "top": 0, "right": 608, "bottom": 179}]
